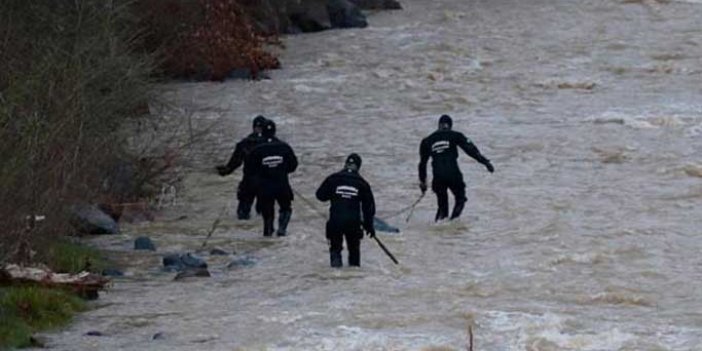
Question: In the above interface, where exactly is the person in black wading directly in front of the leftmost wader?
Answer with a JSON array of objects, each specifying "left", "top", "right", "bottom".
[{"left": 244, "top": 120, "right": 297, "bottom": 236}]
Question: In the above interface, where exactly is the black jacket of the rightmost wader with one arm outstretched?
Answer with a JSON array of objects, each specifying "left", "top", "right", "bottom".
[{"left": 419, "top": 130, "right": 490, "bottom": 183}]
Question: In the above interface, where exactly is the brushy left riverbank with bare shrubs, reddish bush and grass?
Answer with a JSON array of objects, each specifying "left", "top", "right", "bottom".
[{"left": 0, "top": 0, "right": 400, "bottom": 349}]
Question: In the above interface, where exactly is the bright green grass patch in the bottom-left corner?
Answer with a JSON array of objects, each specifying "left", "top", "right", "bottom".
[{"left": 0, "top": 287, "right": 85, "bottom": 347}]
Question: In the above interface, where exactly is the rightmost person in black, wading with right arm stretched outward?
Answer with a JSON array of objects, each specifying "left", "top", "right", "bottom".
[{"left": 419, "top": 115, "right": 495, "bottom": 221}]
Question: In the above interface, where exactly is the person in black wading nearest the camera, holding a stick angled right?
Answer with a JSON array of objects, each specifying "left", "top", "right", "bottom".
[{"left": 316, "top": 154, "right": 375, "bottom": 267}]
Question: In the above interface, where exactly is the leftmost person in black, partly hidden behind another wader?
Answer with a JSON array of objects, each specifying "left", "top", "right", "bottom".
[{"left": 217, "top": 115, "right": 266, "bottom": 220}]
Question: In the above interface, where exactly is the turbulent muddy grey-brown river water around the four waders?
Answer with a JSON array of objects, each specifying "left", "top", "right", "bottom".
[{"left": 37, "top": 0, "right": 702, "bottom": 351}]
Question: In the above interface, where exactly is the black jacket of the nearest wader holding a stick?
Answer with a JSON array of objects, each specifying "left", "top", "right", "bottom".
[{"left": 316, "top": 169, "right": 375, "bottom": 231}]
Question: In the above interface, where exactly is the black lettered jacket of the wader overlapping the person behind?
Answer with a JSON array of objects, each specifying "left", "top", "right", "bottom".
[{"left": 244, "top": 138, "right": 297, "bottom": 185}]
